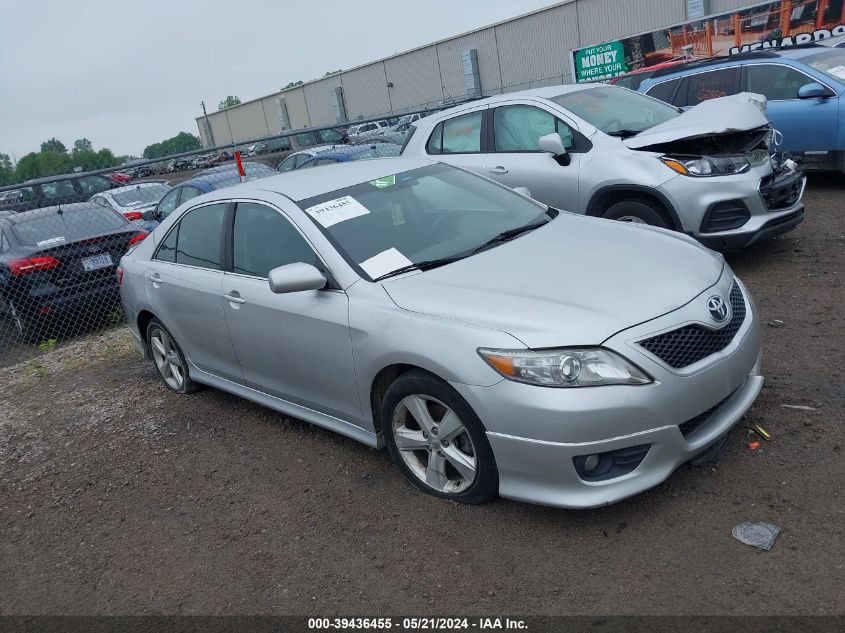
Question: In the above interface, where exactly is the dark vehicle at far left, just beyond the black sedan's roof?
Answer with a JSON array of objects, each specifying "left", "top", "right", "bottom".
[{"left": 0, "top": 174, "right": 122, "bottom": 212}]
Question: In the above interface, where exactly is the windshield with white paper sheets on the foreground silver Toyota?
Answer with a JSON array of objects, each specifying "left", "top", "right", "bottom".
[{"left": 297, "top": 165, "right": 555, "bottom": 279}]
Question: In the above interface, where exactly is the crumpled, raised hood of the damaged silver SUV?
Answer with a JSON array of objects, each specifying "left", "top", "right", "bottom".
[{"left": 623, "top": 92, "right": 769, "bottom": 149}]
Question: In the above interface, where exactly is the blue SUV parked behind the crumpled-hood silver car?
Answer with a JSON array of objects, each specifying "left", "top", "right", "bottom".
[{"left": 638, "top": 45, "right": 845, "bottom": 172}]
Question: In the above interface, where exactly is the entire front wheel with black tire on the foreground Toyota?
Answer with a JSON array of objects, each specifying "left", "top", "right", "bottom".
[{"left": 381, "top": 371, "right": 499, "bottom": 504}]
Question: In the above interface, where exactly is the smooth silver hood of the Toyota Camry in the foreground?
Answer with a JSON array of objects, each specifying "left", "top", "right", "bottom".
[{"left": 383, "top": 213, "right": 723, "bottom": 349}]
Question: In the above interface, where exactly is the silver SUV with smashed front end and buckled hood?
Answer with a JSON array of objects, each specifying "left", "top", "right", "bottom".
[{"left": 403, "top": 84, "right": 806, "bottom": 251}]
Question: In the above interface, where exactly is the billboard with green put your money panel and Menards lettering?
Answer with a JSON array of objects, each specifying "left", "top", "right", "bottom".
[{"left": 572, "top": 0, "right": 845, "bottom": 82}]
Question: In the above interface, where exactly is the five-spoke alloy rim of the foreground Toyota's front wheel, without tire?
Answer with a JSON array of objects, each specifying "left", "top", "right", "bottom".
[{"left": 392, "top": 394, "right": 477, "bottom": 494}]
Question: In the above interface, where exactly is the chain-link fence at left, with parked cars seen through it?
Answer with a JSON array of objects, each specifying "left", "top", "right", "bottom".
[{"left": 0, "top": 111, "right": 442, "bottom": 364}]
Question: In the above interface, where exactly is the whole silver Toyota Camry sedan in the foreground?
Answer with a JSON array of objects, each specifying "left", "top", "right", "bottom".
[{"left": 118, "top": 158, "right": 763, "bottom": 508}]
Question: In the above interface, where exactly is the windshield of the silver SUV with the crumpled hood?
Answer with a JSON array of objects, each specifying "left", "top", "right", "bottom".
[{"left": 552, "top": 86, "right": 680, "bottom": 136}]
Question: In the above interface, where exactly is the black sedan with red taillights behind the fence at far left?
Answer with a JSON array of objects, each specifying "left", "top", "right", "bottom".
[{"left": 0, "top": 202, "right": 147, "bottom": 340}]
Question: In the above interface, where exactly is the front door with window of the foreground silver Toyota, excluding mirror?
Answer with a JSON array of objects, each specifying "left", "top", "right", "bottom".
[{"left": 222, "top": 202, "right": 361, "bottom": 424}]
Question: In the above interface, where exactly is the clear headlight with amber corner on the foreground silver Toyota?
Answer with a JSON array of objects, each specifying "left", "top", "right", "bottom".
[{"left": 478, "top": 347, "right": 652, "bottom": 387}]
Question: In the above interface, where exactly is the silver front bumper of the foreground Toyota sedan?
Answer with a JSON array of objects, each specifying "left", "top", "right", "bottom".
[{"left": 453, "top": 274, "right": 763, "bottom": 508}]
